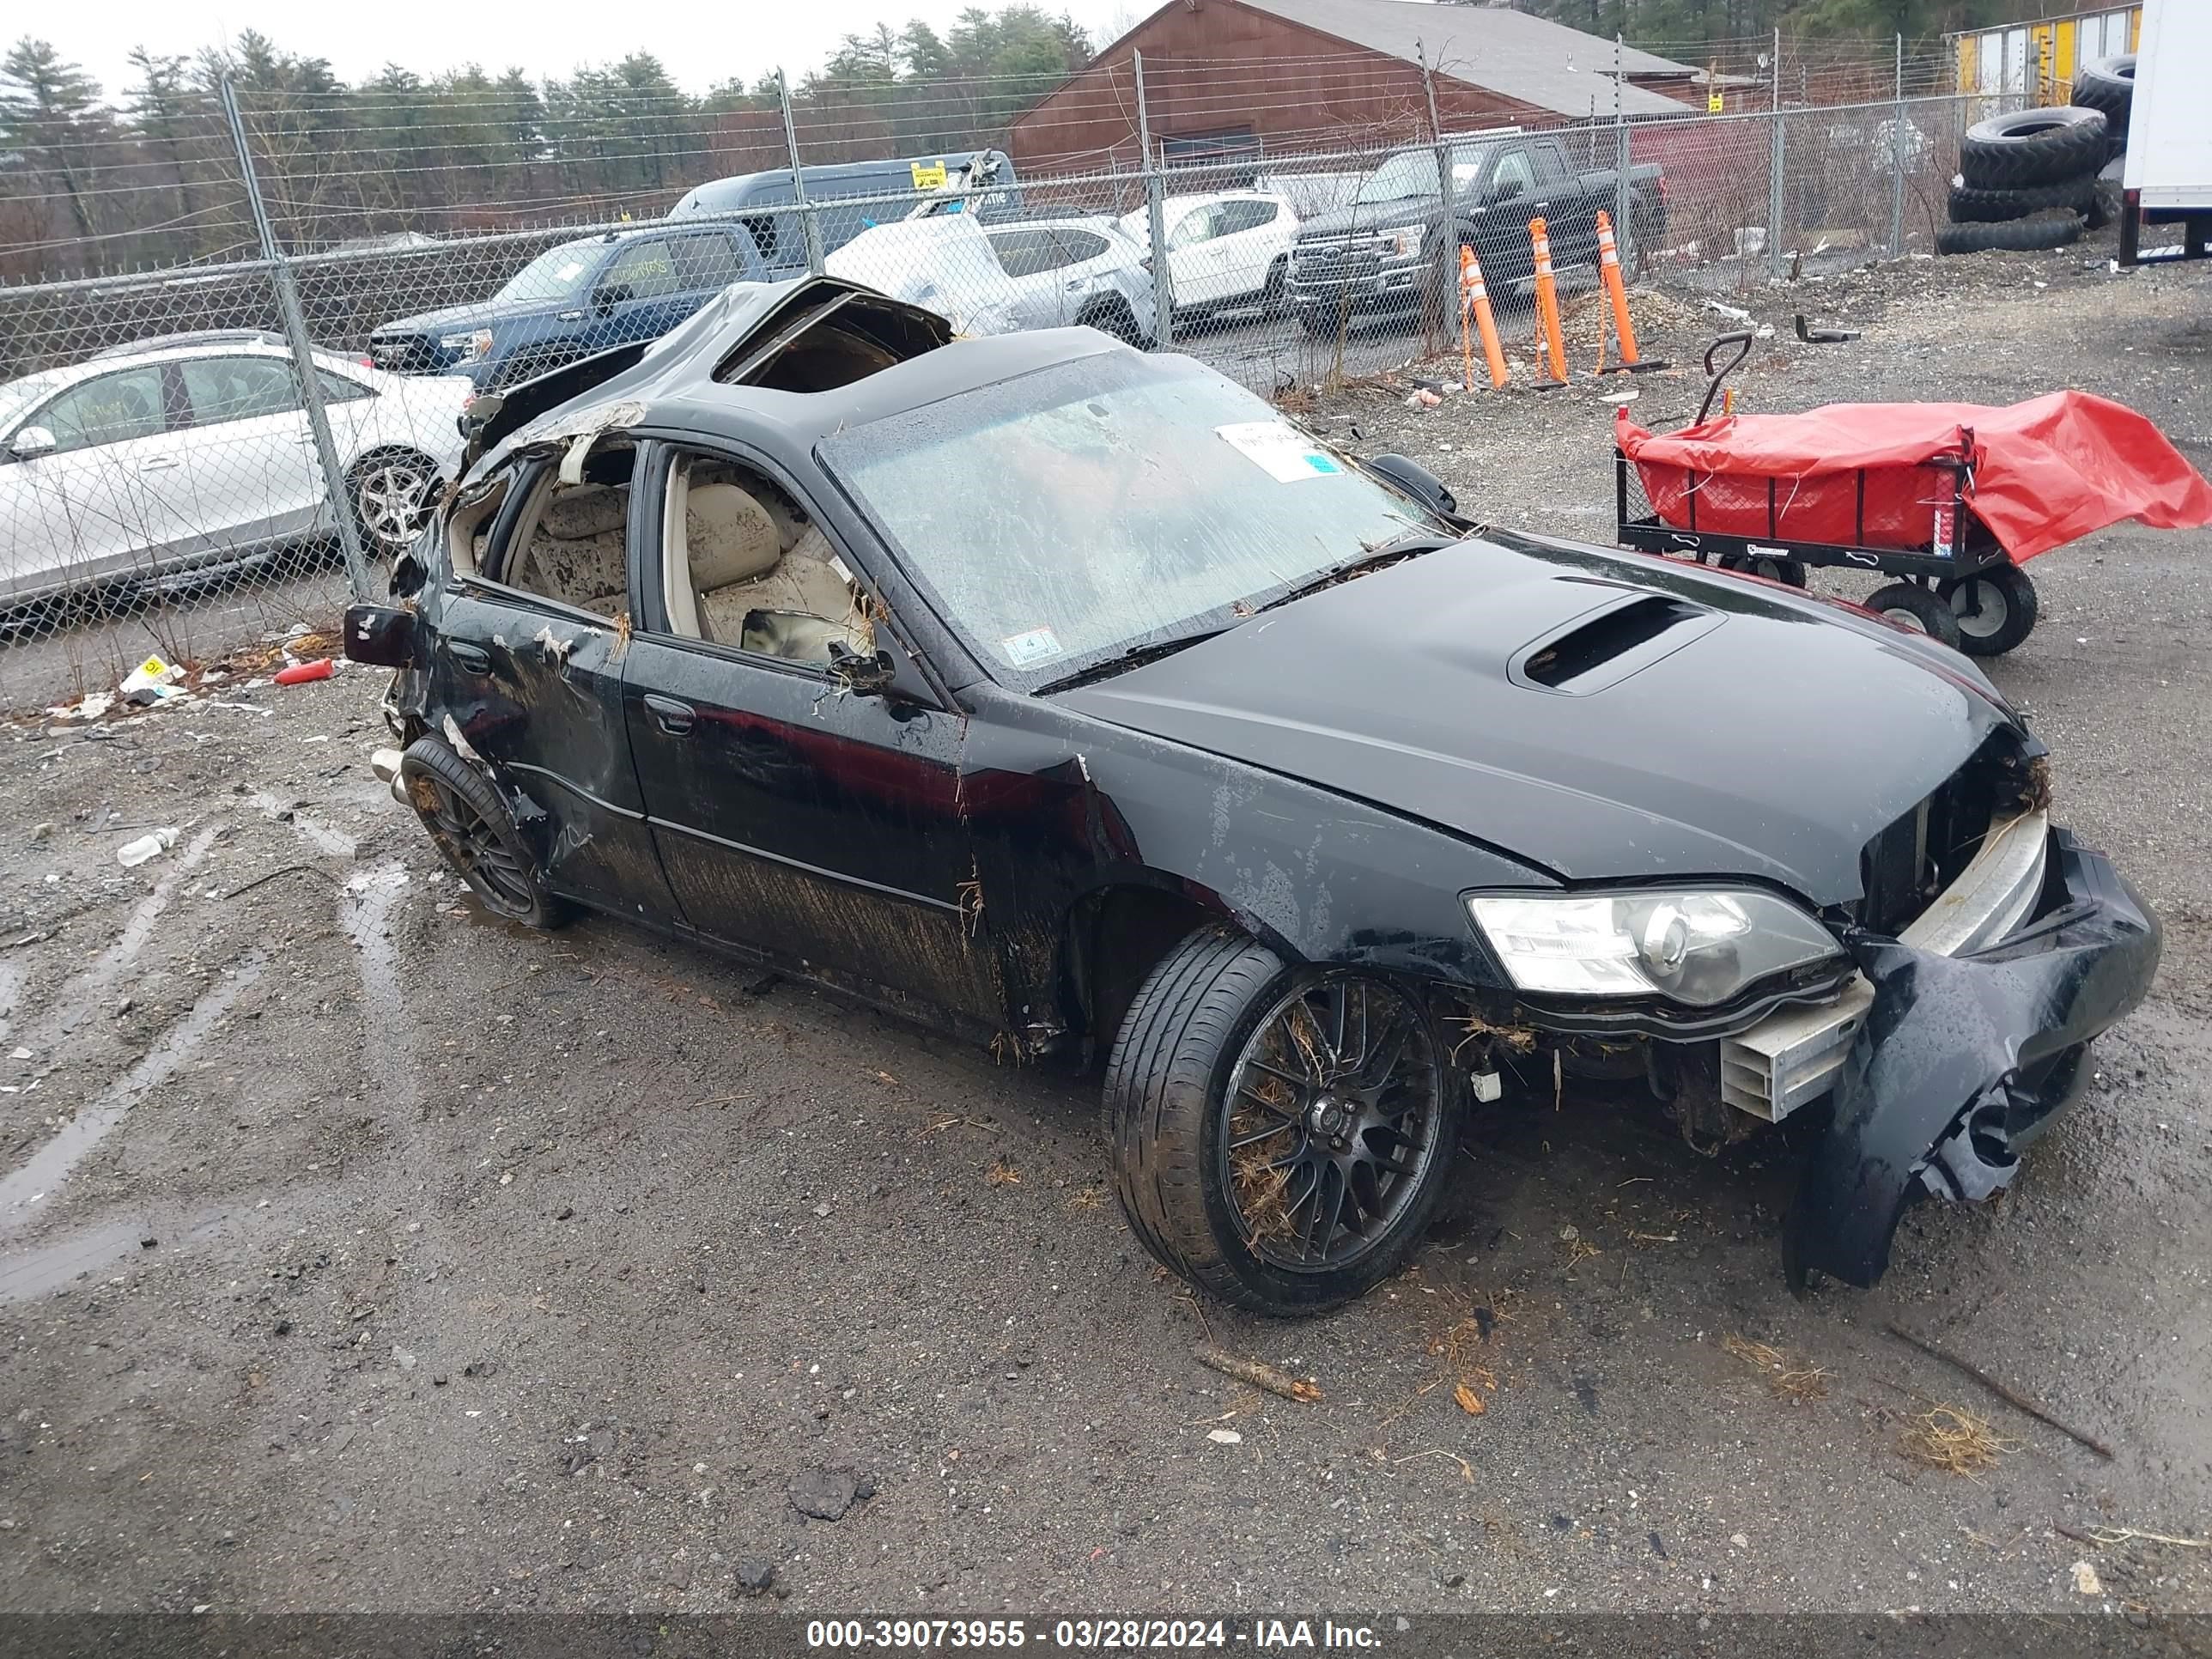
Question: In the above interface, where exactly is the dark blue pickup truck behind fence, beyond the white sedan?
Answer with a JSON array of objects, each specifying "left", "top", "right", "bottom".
[{"left": 369, "top": 223, "right": 769, "bottom": 392}]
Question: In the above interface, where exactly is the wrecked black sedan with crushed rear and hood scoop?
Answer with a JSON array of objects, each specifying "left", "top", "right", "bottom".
[{"left": 347, "top": 279, "right": 2159, "bottom": 1314}]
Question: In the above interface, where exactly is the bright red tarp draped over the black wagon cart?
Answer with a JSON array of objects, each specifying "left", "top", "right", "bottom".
[{"left": 1617, "top": 392, "right": 2212, "bottom": 560}]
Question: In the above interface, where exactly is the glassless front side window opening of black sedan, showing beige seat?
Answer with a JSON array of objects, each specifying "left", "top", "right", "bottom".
[{"left": 661, "top": 453, "right": 876, "bottom": 665}]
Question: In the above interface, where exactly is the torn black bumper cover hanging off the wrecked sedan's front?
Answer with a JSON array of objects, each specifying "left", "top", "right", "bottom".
[{"left": 1783, "top": 830, "right": 2159, "bottom": 1290}]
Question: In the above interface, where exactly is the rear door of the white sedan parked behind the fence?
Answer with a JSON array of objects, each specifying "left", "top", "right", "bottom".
[{"left": 173, "top": 354, "right": 325, "bottom": 550}]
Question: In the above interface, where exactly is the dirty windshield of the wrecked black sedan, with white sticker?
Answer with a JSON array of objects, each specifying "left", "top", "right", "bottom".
[{"left": 821, "top": 356, "right": 1437, "bottom": 686}]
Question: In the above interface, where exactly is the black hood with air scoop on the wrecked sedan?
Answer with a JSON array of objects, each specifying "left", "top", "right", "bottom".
[{"left": 1055, "top": 533, "right": 2013, "bottom": 905}]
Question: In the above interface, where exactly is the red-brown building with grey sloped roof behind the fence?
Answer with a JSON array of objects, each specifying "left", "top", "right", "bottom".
[{"left": 1011, "top": 0, "right": 1705, "bottom": 175}]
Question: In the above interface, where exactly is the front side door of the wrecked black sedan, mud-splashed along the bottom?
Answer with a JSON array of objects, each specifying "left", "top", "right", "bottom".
[{"left": 622, "top": 447, "right": 1000, "bottom": 1022}]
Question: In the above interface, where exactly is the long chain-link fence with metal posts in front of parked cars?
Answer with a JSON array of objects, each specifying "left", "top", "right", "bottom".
[{"left": 0, "top": 57, "right": 2070, "bottom": 706}]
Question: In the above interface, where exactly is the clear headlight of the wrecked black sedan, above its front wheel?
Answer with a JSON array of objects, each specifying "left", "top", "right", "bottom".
[{"left": 1467, "top": 890, "right": 1843, "bottom": 1009}]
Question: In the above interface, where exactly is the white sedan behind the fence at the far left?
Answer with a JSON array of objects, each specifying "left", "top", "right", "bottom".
[{"left": 0, "top": 338, "right": 476, "bottom": 606}]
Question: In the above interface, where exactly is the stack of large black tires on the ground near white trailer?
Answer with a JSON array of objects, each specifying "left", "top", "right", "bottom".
[{"left": 1936, "top": 96, "right": 2132, "bottom": 254}]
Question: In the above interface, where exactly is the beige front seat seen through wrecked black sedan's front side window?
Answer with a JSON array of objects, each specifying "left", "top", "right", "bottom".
[{"left": 684, "top": 484, "right": 872, "bottom": 661}]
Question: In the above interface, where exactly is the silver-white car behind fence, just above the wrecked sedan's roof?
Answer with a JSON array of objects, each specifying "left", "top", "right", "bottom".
[{"left": 825, "top": 212, "right": 1152, "bottom": 345}]
